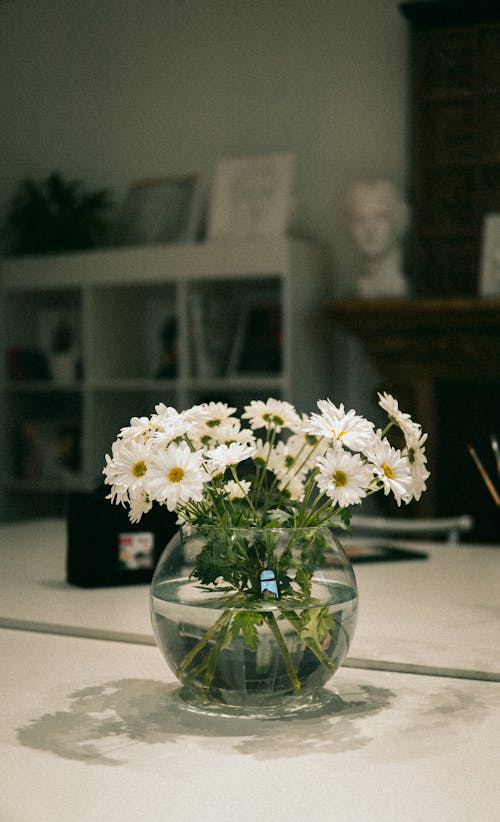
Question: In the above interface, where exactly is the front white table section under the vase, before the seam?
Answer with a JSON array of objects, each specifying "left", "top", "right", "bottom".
[{"left": 0, "top": 632, "right": 500, "bottom": 822}]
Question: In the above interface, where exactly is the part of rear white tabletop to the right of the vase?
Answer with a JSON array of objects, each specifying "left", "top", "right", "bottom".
[{"left": 350, "top": 543, "right": 500, "bottom": 681}]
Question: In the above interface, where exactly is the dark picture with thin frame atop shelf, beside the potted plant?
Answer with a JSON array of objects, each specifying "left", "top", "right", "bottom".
[{"left": 115, "top": 174, "right": 203, "bottom": 246}]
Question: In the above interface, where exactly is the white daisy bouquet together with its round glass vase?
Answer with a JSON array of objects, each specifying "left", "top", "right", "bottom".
[{"left": 104, "top": 394, "right": 429, "bottom": 712}]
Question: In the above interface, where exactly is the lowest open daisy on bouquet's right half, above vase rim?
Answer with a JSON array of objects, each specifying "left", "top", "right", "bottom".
[{"left": 316, "top": 449, "right": 373, "bottom": 508}]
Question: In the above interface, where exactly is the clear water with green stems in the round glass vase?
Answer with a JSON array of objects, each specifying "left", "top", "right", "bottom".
[{"left": 151, "top": 579, "right": 357, "bottom": 706}]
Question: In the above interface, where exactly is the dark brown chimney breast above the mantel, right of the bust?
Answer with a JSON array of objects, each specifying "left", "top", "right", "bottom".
[{"left": 400, "top": 0, "right": 500, "bottom": 296}]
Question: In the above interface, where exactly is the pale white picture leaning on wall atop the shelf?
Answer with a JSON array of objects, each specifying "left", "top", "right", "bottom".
[{"left": 207, "top": 152, "right": 295, "bottom": 239}]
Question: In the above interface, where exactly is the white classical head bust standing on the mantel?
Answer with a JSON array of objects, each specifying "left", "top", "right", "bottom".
[{"left": 347, "top": 180, "right": 408, "bottom": 297}]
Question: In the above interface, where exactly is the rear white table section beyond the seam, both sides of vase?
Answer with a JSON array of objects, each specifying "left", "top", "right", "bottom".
[{"left": 0, "top": 519, "right": 500, "bottom": 681}]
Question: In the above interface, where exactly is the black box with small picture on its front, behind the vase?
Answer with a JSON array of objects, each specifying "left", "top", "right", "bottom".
[{"left": 66, "top": 488, "right": 178, "bottom": 588}]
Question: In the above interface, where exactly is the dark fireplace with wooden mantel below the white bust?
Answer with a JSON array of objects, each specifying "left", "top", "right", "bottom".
[{"left": 323, "top": 296, "right": 500, "bottom": 543}]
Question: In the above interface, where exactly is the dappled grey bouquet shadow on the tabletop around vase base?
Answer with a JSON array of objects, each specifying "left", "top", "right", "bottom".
[{"left": 17, "top": 679, "right": 394, "bottom": 766}]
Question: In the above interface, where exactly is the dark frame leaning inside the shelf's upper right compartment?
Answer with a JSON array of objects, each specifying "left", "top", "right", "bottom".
[{"left": 228, "top": 298, "right": 283, "bottom": 376}]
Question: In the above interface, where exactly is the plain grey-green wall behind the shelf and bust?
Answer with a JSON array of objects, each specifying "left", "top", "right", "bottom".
[{"left": 0, "top": 0, "right": 407, "bottom": 408}]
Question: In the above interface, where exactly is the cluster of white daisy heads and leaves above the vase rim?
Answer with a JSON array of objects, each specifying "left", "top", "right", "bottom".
[{"left": 104, "top": 393, "right": 429, "bottom": 528}]
